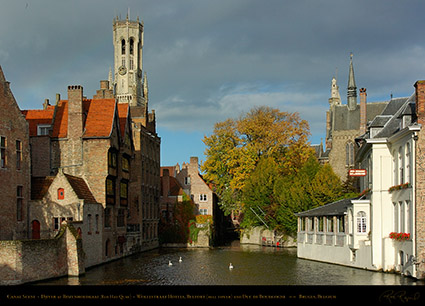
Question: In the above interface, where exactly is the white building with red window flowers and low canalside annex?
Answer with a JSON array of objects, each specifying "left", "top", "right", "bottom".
[{"left": 297, "top": 89, "right": 420, "bottom": 277}]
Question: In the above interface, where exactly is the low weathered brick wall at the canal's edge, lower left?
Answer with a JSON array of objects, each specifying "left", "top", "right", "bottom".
[{"left": 0, "top": 224, "right": 85, "bottom": 285}]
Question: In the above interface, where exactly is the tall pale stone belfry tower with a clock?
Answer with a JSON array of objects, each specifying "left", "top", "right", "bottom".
[{"left": 109, "top": 15, "right": 147, "bottom": 107}]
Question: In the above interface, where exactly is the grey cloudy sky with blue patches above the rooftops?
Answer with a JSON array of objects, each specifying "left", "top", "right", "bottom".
[{"left": 0, "top": 0, "right": 425, "bottom": 165}]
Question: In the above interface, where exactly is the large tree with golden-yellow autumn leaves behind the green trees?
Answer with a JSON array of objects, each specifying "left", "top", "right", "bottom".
[{"left": 201, "top": 106, "right": 312, "bottom": 214}]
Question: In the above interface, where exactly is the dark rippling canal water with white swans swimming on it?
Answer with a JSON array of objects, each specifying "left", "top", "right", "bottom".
[{"left": 34, "top": 241, "right": 424, "bottom": 286}]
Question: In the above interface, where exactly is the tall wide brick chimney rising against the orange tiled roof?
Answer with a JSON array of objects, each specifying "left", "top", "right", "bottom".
[{"left": 68, "top": 85, "right": 83, "bottom": 139}]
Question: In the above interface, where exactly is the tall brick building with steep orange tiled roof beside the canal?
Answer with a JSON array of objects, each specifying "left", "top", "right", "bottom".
[{"left": 23, "top": 81, "right": 140, "bottom": 260}]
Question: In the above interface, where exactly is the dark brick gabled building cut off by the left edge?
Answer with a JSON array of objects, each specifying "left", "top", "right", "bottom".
[{"left": 0, "top": 66, "right": 30, "bottom": 240}]
